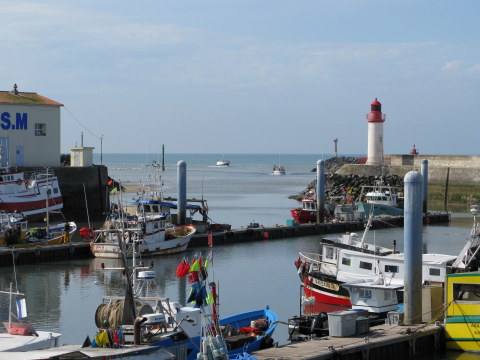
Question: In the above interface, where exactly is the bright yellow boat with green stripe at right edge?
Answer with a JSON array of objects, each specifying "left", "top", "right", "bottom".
[{"left": 445, "top": 271, "right": 480, "bottom": 355}]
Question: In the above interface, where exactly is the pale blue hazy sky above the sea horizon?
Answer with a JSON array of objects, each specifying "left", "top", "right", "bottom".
[{"left": 0, "top": 0, "right": 480, "bottom": 155}]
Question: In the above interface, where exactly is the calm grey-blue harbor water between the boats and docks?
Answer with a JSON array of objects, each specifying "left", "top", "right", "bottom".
[{"left": 0, "top": 154, "right": 472, "bottom": 359}]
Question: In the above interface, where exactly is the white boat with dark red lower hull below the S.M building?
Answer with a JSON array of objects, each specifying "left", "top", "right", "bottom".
[{"left": 0, "top": 168, "right": 63, "bottom": 220}]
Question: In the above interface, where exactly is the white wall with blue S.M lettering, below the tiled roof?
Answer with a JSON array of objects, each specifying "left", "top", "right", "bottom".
[{"left": 0, "top": 104, "right": 61, "bottom": 167}]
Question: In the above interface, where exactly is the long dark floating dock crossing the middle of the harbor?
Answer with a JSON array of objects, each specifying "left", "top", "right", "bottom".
[{"left": 0, "top": 213, "right": 450, "bottom": 266}]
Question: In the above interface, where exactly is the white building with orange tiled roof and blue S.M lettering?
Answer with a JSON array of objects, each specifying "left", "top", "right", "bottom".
[{"left": 0, "top": 84, "right": 63, "bottom": 167}]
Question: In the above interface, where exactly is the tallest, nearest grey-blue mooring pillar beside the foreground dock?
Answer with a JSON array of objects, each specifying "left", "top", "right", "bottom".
[{"left": 403, "top": 171, "right": 423, "bottom": 325}]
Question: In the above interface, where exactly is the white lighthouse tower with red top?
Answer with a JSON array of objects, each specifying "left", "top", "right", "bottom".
[{"left": 367, "top": 98, "right": 385, "bottom": 165}]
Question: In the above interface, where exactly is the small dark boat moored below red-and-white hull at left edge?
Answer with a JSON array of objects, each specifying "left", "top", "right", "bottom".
[{"left": 0, "top": 213, "right": 77, "bottom": 248}]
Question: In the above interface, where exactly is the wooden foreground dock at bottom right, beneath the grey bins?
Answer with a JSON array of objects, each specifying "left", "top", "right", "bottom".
[{"left": 252, "top": 324, "right": 443, "bottom": 360}]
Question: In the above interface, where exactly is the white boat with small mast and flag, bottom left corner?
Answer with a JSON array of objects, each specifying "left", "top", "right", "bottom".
[{"left": 0, "top": 283, "right": 61, "bottom": 350}]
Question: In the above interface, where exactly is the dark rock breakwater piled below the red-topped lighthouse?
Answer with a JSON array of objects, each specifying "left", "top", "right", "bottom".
[{"left": 289, "top": 156, "right": 403, "bottom": 201}]
